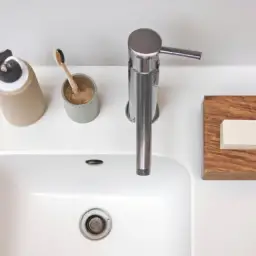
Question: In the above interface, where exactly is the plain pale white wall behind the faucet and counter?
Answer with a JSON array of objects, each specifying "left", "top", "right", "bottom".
[{"left": 0, "top": 0, "right": 256, "bottom": 65}]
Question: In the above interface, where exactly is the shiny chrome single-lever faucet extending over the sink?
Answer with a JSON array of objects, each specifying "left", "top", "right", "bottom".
[{"left": 126, "top": 28, "right": 201, "bottom": 176}]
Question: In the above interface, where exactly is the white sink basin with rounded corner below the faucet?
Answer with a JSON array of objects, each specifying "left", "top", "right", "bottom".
[{"left": 0, "top": 155, "right": 191, "bottom": 256}]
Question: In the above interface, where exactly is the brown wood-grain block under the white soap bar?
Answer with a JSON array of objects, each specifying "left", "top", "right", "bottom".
[{"left": 202, "top": 96, "right": 256, "bottom": 180}]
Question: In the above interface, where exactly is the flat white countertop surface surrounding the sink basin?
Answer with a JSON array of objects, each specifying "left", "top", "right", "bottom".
[{"left": 0, "top": 66, "right": 256, "bottom": 256}]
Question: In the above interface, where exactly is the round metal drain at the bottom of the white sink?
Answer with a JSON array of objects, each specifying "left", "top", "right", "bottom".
[{"left": 79, "top": 208, "right": 112, "bottom": 240}]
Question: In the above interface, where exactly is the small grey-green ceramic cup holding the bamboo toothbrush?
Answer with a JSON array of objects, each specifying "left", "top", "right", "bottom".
[{"left": 61, "top": 74, "right": 100, "bottom": 123}]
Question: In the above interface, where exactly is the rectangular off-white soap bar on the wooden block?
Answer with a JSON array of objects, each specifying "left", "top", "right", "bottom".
[{"left": 220, "top": 120, "right": 256, "bottom": 150}]
